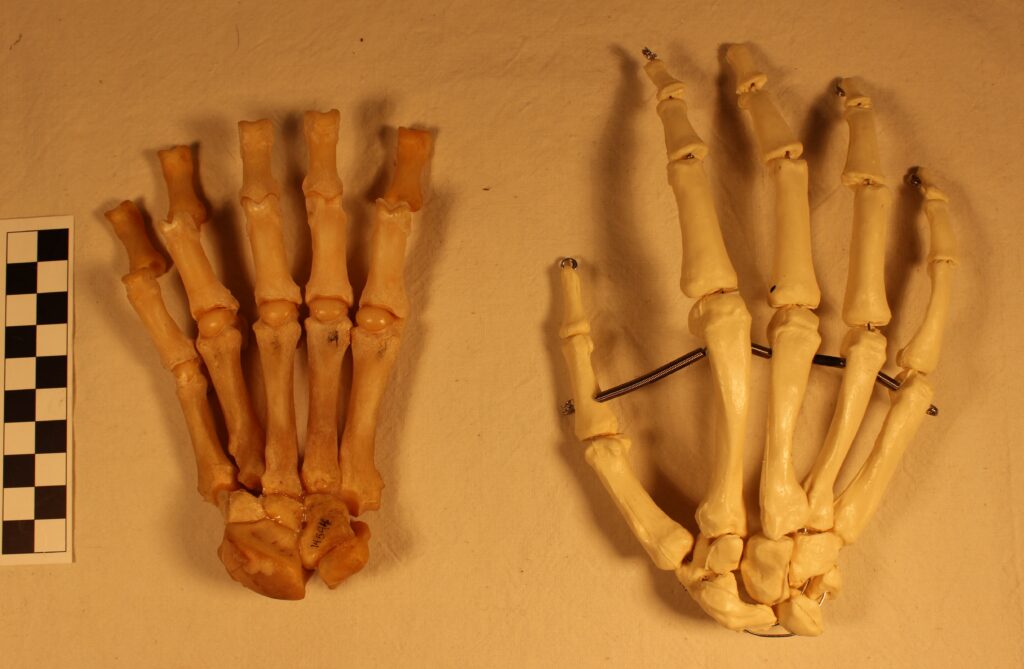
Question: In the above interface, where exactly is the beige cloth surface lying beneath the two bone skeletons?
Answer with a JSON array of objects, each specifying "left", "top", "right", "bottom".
[{"left": 0, "top": 0, "right": 1024, "bottom": 667}]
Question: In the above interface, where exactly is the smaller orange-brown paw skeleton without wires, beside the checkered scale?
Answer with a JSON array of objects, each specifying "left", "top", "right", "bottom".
[{"left": 99, "top": 110, "right": 432, "bottom": 599}]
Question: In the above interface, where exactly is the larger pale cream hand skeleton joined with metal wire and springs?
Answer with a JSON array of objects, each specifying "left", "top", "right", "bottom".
[{"left": 559, "top": 45, "right": 956, "bottom": 635}]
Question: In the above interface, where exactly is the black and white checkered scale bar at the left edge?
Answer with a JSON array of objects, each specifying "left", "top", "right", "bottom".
[{"left": 0, "top": 216, "right": 75, "bottom": 566}]
